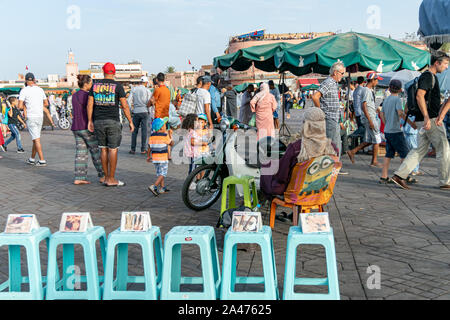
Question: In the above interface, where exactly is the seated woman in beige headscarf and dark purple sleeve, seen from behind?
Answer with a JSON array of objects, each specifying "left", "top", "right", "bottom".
[{"left": 261, "top": 108, "right": 339, "bottom": 200}]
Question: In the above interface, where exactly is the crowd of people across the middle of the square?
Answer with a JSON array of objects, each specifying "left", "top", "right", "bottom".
[{"left": 0, "top": 55, "right": 450, "bottom": 196}]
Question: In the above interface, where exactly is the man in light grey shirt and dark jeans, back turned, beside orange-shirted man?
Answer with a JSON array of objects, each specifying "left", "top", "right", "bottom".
[{"left": 128, "top": 76, "right": 152, "bottom": 154}]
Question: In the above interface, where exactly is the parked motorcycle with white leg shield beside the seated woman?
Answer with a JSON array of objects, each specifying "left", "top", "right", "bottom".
[{"left": 182, "top": 117, "right": 286, "bottom": 211}]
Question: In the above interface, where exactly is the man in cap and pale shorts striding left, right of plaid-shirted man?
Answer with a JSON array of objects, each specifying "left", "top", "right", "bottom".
[{"left": 347, "top": 72, "right": 383, "bottom": 167}]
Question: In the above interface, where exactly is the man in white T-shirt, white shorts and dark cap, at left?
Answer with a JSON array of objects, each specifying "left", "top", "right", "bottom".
[{"left": 19, "top": 73, "right": 55, "bottom": 167}]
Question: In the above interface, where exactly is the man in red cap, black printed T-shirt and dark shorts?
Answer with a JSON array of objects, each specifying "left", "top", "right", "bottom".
[{"left": 87, "top": 62, "right": 134, "bottom": 187}]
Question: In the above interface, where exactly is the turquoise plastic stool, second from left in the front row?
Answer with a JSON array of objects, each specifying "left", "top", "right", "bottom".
[{"left": 46, "top": 227, "right": 106, "bottom": 300}]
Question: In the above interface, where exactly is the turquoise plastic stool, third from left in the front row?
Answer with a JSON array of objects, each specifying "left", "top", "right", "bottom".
[{"left": 103, "top": 227, "right": 163, "bottom": 300}]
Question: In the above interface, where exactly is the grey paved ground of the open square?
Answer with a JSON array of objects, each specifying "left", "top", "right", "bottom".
[{"left": 0, "top": 111, "right": 450, "bottom": 300}]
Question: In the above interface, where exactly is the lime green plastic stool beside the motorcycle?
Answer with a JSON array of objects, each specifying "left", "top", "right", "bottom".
[{"left": 220, "top": 176, "right": 258, "bottom": 213}]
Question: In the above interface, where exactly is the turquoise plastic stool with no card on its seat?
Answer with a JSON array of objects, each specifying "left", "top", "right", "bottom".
[{"left": 161, "top": 227, "right": 220, "bottom": 300}]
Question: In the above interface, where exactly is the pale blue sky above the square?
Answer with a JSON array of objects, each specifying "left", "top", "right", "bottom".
[{"left": 0, "top": 0, "right": 422, "bottom": 80}]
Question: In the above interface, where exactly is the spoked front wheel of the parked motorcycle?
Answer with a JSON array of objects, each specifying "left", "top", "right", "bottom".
[{"left": 182, "top": 165, "right": 225, "bottom": 211}]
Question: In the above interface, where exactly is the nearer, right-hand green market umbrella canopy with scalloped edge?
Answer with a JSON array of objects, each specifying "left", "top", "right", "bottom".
[{"left": 275, "top": 32, "right": 430, "bottom": 76}]
